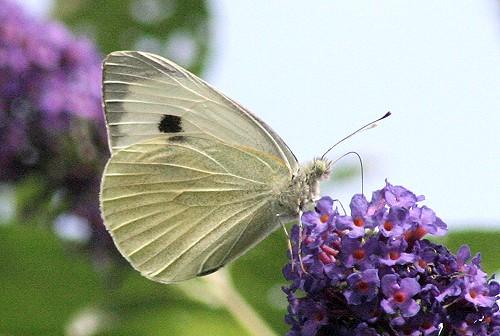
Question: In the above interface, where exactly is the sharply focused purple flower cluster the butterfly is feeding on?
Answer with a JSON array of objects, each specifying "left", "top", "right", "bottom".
[{"left": 283, "top": 182, "right": 500, "bottom": 336}]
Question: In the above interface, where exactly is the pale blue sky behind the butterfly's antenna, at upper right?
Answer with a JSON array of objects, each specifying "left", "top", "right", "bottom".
[{"left": 23, "top": 0, "right": 500, "bottom": 227}]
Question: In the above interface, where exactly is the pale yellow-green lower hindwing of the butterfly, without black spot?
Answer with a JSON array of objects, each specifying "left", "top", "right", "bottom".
[{"left": 101, "top": 134, "right": 291, "bottom": 283}]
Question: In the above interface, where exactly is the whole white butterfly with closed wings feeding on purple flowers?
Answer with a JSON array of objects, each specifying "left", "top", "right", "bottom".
[{"left": 100, "top": 51, "right": 329, "bottom": 283}]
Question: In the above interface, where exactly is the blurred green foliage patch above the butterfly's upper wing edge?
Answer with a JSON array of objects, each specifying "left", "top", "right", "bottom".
[{"left": 54, "top": 0, "right": 211, "bottom": 73}]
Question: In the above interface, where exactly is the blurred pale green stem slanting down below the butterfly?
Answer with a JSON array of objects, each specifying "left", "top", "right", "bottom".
[{"left": 203, "top": 269, "right": 276, "bottom": 336}]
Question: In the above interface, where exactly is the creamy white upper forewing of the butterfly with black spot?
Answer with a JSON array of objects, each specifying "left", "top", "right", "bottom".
[{"left": 103, "top": 51, "right": 298, "bottom": 174}]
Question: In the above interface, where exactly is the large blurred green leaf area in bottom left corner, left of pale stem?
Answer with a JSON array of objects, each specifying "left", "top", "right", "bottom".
[{"left": 0, "top": 224, "right": 256, "bottom": 336}]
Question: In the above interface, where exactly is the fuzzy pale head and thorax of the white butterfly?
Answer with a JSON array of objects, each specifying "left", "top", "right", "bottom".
[{"left": 279, "top": 159, "right": 331, "bottom": 215}]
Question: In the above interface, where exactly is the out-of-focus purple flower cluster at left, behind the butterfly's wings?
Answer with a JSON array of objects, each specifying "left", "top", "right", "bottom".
[{"left": 0, "top": 0, "right": 110, "bottom": 253}]
